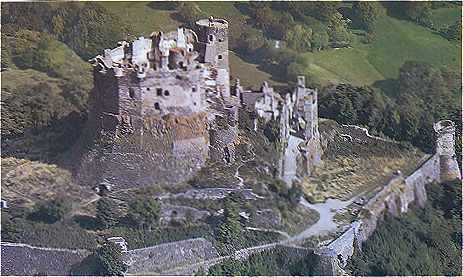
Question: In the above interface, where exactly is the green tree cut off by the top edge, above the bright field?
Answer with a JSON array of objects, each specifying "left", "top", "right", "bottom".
[{"left": 352, "top": 1, "right": 382, "bottom": 33}]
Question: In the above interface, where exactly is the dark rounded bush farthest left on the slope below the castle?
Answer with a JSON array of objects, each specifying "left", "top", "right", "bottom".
[{"left": 31, "top": 198, "right": 72, "bottom": 223}]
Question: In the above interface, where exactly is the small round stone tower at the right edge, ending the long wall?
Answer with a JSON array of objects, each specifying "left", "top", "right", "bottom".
[{"left": 434, "top": 120, "right": 461, "bottom": 182}]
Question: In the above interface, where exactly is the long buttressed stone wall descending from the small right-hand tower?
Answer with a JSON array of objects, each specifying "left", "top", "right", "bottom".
[{"left": 316, "top": 154, "right": 440, "bottom": 275}]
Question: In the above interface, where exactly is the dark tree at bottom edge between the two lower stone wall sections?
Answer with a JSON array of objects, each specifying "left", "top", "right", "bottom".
[{"left": 96, "top": 242, "right": 127, "bottom": 276}]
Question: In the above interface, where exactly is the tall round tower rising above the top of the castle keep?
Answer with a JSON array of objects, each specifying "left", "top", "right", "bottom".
[{"left": 196, "top": 16, "right": 228, "bottom": 71}]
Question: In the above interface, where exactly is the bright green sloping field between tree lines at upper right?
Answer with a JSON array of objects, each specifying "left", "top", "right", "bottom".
[{"left": 296, "top": 13, "right": 461, "bottom": 85}]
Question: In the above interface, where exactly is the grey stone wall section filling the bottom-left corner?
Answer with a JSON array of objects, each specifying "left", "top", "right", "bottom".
[{"left": 1, "top": 242, "right": 90, "bottom": 276}]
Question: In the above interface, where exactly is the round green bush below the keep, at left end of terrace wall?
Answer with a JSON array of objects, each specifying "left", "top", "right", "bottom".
[{"left": 127, "top": 197, "right": 160, "bottom": 228}]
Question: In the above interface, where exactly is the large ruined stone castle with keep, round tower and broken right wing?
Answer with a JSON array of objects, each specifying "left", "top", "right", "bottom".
[{"left": 84, "top": 17, "right": 320, "bottom": 189}]
